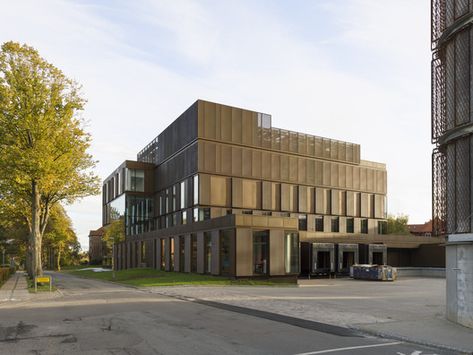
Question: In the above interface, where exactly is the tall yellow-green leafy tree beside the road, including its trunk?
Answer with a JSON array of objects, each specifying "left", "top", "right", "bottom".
[{"left": 0, "top": 42, "right": 99, "bottom": 277}]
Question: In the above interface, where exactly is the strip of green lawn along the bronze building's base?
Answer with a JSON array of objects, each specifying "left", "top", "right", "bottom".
[{"left": 65, "top": 268, "right": 295, "bottom": 287}]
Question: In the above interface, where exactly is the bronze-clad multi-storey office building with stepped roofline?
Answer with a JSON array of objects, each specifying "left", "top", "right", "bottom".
[{"left": 103, "top": 100, "right": 438, "bottom": 277}]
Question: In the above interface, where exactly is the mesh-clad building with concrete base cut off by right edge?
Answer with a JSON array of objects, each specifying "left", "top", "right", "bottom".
[{"left": 432, "top": 0, "right": 473, "bottom": 327}]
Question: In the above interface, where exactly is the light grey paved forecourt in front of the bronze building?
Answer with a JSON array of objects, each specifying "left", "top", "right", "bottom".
[{"left": 148, "top": 278, "right": 473, "bottom": 353}]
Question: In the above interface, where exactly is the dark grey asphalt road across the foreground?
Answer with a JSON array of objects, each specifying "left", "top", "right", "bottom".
[{"left": 0, "top": 273, "right": 458, "bottom": 355}]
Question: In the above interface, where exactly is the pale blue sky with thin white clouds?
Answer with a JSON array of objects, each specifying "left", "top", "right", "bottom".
[{"left": 0, "top": 0, "right": 432, "bottom": 249}]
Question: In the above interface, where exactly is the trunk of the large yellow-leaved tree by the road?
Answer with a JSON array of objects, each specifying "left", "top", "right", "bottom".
[{"left": 30, "top": 180, "right": 43, "bottom": 277}]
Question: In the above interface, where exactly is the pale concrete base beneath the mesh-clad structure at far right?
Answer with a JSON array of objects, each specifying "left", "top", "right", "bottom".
[{"left": 446, "top": 234, "right": 473, "bottom": 328}]
